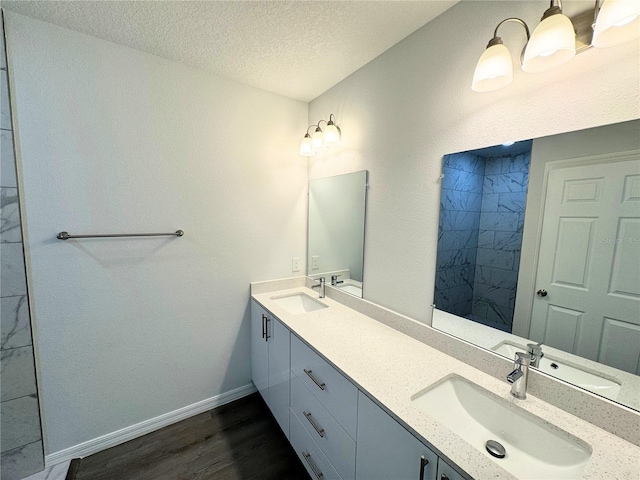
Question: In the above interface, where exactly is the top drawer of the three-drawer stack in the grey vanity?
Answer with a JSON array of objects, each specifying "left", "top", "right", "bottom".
[{"left": 291, "top": 335, "right": 358, "bottom": 439}]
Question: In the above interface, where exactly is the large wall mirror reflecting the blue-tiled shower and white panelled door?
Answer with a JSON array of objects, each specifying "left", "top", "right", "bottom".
[{"left": 432, "top": 120, "right": 640, "bottom": 410}]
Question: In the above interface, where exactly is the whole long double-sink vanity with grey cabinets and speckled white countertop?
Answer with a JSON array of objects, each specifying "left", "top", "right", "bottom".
[{"left": 251, "top": 277, "right": 640, "bottom": 480}]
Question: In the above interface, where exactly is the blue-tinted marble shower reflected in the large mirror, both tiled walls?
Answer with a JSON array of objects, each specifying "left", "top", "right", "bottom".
[{"left": 434, "top": 141, "right": 531, "bottom": 333}]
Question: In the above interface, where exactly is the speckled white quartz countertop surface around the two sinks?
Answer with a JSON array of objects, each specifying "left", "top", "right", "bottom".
[{"left": 252, "top": 287, "right": 640, "bottom": 480}]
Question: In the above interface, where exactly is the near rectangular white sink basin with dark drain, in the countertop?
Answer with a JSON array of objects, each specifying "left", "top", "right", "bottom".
[{"left": 411, "top": 375, "right": 592, "bottom": 480}]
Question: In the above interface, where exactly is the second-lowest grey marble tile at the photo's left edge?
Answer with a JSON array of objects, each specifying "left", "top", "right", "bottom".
[{"left": 0, "top": 395, "right": 42, "bottom": 452}]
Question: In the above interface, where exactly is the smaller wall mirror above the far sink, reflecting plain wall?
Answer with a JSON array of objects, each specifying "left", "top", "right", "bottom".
[{"left": 307, "top": 170, "right": 367, "bottom": 297}]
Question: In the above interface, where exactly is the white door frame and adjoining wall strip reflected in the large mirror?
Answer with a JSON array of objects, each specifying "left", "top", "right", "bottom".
[{"left": 512, "top": 149, "right": 640, "bottom": 338}]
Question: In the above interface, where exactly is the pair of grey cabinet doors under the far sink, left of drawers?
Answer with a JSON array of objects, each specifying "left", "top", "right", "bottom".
[{"left": 251, "top": 301, "right": 291, "bottom": 438}]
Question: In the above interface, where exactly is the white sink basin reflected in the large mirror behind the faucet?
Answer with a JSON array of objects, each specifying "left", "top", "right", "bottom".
[{"left": 492, "top": 342, "right": 621, "bottom": 400}]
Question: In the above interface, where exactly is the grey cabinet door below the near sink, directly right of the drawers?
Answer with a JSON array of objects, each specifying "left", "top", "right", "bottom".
[{"left": 356, "top": 392, "right": 438, "bottom": 480}]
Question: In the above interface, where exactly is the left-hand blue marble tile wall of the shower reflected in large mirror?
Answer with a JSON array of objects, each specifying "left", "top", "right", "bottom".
[{"left": 434, "top": 152, "right": 485, "bottom": 316}]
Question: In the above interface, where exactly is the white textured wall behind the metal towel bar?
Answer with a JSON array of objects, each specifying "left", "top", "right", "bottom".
[{"left": 7, "top": 13, "right": 307, "bottom": 454}]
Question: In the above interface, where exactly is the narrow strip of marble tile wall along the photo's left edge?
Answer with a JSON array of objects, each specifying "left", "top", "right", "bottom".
[{"left": 0, "top": 16, "right": 44, "bottom": 480}]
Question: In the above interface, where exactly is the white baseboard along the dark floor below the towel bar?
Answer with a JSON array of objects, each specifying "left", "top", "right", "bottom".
[{"left": 44, "top": 383, "right": 256, "bottom": 468}]
